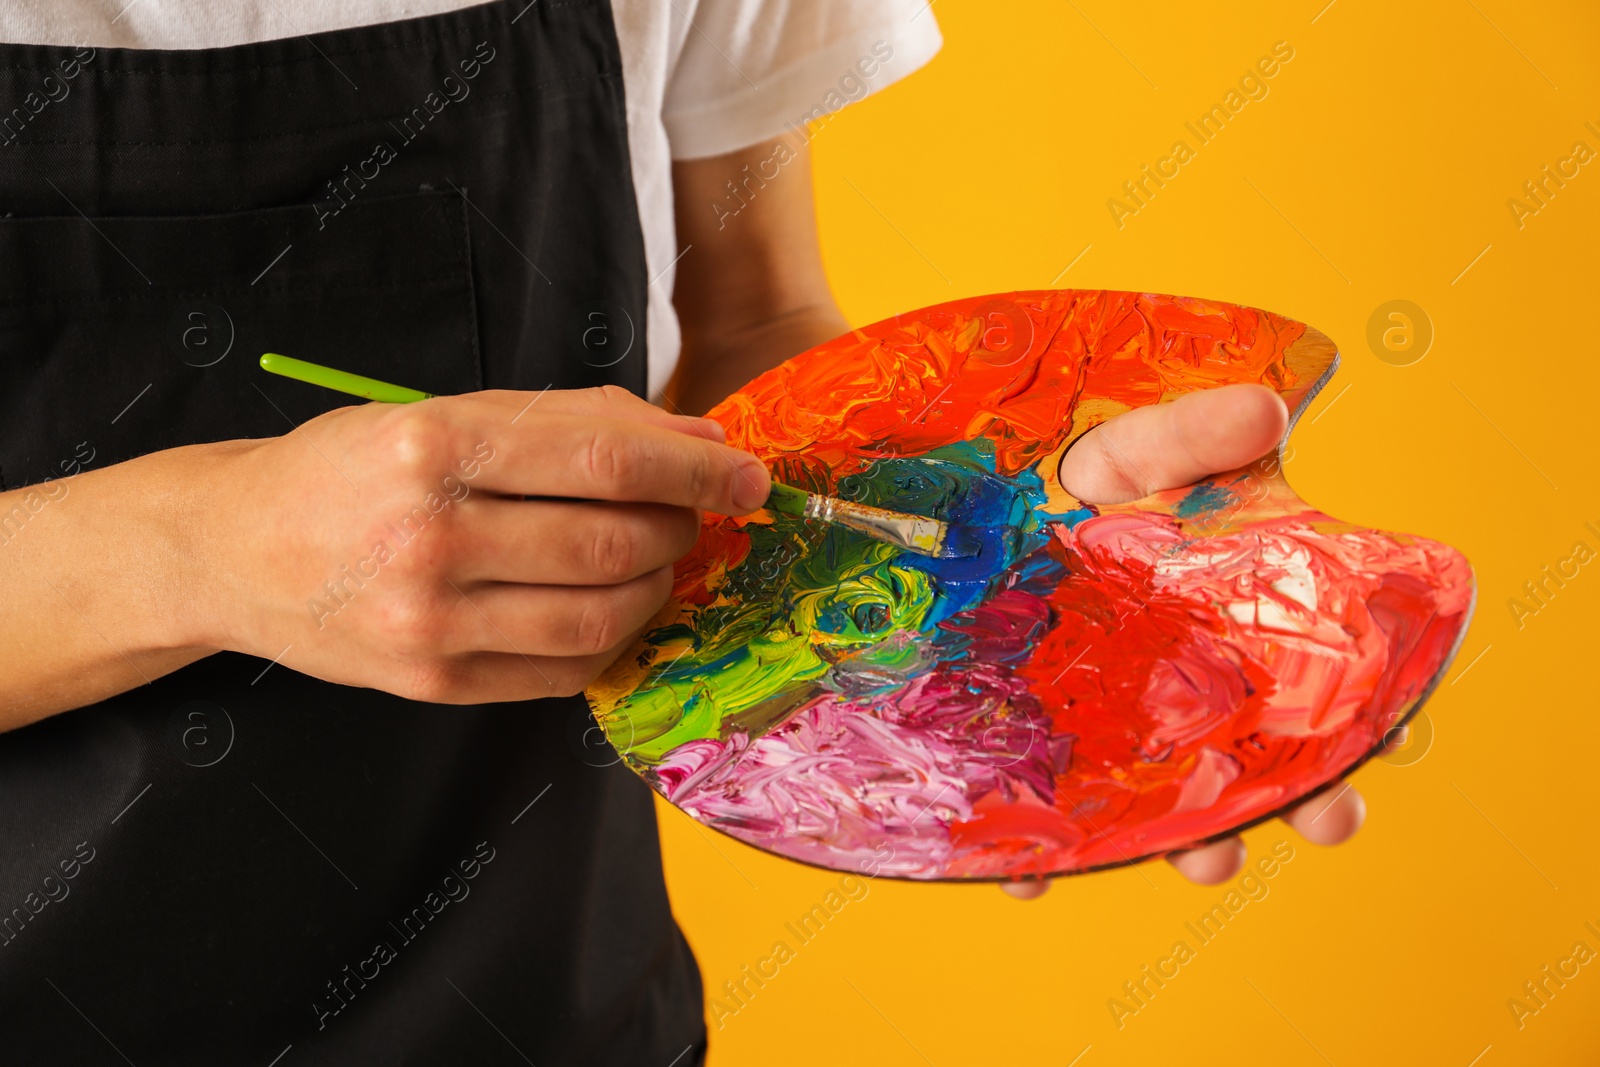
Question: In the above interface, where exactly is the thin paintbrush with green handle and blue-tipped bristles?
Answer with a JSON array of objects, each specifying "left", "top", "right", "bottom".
[{"left": 261, "top": 352, "right": 982, "bottom": 560}]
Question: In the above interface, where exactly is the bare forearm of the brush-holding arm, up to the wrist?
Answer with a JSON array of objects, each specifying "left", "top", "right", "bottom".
[{"left": 0, "top": 443, "right": 227, "bottom": 731}]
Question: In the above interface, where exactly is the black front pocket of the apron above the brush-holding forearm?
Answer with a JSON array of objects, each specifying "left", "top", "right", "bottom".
[{"left": 0, "top": 192, "right": 483, "bottom": 488}]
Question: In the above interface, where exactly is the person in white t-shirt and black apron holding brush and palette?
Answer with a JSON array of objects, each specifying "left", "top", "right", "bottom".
[{"left": 0, "top": 0, "right": 1362, "bottom": 1067}]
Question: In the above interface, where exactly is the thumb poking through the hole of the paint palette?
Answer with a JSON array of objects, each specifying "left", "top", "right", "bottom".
[{"left": 1061, "top": 386, "right": 1288, "bottom": 504}]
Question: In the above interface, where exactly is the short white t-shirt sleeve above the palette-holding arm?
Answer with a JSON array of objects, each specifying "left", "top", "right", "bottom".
[{"left": 662, "top": 0, "right": 942, "bottom": 160}]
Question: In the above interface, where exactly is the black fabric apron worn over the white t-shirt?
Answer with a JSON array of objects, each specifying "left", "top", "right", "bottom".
[{"left": 0, "top": 0, "right": 706, "bottom": 1067}]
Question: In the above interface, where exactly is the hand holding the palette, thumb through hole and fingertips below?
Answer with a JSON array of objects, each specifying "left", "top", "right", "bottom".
[{"left": 1002, "top": 386, "right": 1366, "bottom": 899}]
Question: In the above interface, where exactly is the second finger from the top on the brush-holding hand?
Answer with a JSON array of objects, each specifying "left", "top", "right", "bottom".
[{"left": 451, "top": 496, "right": 701, "bottom": 585}]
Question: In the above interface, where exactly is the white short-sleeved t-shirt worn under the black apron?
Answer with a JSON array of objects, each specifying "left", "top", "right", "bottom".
[{"left": 0, "top": 0, "right": 942, "bottom": 395}]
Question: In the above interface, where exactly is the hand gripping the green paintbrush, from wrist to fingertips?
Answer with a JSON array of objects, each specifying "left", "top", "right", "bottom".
[{"left": 195, "top": 387, "right": 771, "bottom": 704}]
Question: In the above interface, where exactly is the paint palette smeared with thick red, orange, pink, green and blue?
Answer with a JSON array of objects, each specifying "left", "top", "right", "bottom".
[{"left": 589, "top": 290, "right": 1474, "bottom": 880}]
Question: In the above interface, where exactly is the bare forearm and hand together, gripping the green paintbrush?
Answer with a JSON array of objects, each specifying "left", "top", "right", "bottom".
[{"left": 0, "top": 387, "right": 771, "bottom": 728}]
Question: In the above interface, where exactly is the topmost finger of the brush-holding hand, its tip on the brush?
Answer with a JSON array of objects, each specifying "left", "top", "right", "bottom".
[{"left": 480, "top": 414, "right": 773, "bottom": 515}]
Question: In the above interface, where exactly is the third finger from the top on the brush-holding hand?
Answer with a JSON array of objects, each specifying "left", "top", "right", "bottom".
[{"left": 441, "top": 566, "right": 672, "bottom": 657}]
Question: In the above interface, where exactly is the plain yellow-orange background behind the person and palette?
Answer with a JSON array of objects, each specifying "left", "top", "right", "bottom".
[{"left": 661, "top": 0, "right": 1600, "bottom": 1067}]
